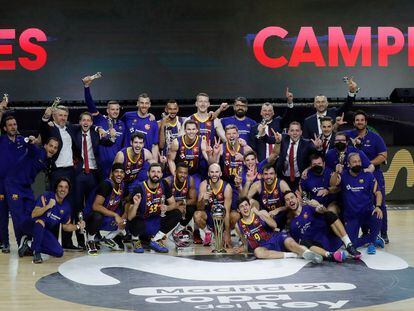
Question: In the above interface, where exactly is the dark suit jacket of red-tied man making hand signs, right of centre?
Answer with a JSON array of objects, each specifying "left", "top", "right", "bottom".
[{"left": 276, "top": 135, "right": 318, "bottom": 176}]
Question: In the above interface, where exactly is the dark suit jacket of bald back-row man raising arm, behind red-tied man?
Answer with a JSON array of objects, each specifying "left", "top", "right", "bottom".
[{"left": 247, "top": 108, "right": 295, "bottom": 162}]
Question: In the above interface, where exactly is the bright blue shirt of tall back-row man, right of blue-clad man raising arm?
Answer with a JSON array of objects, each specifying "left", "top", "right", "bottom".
[{"left": 121, "top": 111, "right": 158, "bottom": 151}]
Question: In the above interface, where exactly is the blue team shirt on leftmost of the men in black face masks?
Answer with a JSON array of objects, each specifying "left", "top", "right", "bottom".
[{"left": 300, "top": 167, "right": 333, "bottom": 206}]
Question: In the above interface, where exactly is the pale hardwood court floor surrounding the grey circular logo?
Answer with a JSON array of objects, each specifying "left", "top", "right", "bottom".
[{"left": 0, "top": 210, "right": 414, "bottom": 311}]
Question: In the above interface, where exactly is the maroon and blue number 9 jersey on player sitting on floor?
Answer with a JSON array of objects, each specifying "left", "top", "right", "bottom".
[{"left": 237, "top": 214, "right": 273, "bottom": 249}]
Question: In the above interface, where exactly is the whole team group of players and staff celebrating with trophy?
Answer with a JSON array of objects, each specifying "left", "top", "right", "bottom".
[{"left": 0, "top": 75, "right": 389, "bottom": 263}]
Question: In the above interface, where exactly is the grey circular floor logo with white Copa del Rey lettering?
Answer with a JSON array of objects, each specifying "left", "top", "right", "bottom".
[{"left": 36, "top": 251, "right": 414, "bottom": 311}]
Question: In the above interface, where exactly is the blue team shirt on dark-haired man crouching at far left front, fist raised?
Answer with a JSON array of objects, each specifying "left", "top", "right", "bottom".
[{"left": 33, "top": 191, "right": 71, "bottom": 229}]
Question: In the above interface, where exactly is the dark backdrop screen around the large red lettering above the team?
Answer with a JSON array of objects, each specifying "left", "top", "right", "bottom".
[{"left": 0, "top": 0, "right": 414, "bottom": 101}]
